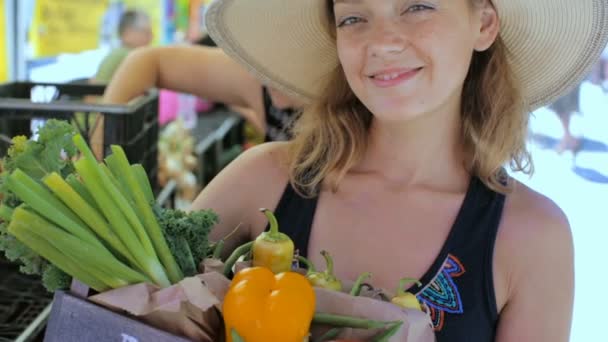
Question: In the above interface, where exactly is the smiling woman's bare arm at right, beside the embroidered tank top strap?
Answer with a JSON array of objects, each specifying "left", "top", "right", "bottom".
[{"left": 495, "top": 191, "right": 574, "bottom": 342}]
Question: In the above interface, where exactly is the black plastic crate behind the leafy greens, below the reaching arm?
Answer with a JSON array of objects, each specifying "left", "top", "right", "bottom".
[{"left": 0, "top": 82, "right": 159, "bottom": 184}]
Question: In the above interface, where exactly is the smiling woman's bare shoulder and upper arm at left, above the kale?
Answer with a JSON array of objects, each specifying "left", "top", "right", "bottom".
[{"left": 191, "top": 142, "right": 288, "bottom": 246}]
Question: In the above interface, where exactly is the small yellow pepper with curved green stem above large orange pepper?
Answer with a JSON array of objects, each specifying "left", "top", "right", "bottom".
[{"left": 252, "top": 209, "right": 294, "bottom": 274}]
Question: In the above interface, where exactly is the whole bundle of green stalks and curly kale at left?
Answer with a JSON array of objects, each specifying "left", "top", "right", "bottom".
[{"left": 0, "top": 120, "right": 218, "bottom": 291}]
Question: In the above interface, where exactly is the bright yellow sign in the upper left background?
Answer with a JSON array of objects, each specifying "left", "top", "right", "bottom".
[{"left": 29, "top": 0, "right": 108, "bottom": 57}]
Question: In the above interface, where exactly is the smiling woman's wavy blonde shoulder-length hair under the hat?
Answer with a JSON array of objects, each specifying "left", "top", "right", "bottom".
[{"left": 289, "top": 0, "right": 533, "bottom": 196}]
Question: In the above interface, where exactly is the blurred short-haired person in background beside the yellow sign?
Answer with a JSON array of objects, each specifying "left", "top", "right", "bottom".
[{"left": 92, "top": 10, "right": 152, "bottom": 84}]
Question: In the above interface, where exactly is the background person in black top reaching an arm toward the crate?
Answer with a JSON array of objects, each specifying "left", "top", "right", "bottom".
[{"left": 104, "top": 41, "right": 300, "bottom": 141}]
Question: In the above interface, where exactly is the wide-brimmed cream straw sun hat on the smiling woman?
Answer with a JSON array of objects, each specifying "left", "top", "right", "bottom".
[{"left": 206, "top": 0, "right": 608, "bottom": 110}]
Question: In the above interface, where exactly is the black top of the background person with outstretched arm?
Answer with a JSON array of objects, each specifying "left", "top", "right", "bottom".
[{"left": 262, "top": 87, "right": 296, "bottom": 142}]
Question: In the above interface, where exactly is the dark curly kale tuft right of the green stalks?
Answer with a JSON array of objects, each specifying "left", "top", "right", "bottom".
[{"left": 154, "top": 206, "right": 219, "bottom": 276}]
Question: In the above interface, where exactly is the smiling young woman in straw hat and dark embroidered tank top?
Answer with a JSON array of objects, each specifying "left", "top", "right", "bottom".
[{"left": 193, "top": 0, "right": 608, "bottom": 342}]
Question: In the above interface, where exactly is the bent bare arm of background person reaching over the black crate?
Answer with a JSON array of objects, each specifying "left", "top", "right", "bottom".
[{"left": 104, "top": 45, "right": 262, "bottom": 120}]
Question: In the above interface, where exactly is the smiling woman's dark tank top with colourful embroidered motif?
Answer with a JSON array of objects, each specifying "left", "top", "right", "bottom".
[{"left": 275, "top": 177, "right": 505, "bottom": 342}]
